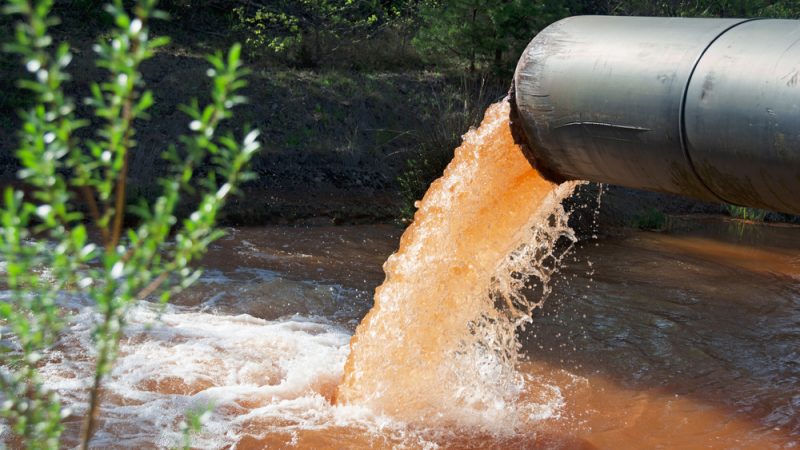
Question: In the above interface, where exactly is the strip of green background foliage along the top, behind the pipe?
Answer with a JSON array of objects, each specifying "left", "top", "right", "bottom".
[{"left": 223, "top": 0, "right": 800, "bottom": 74}]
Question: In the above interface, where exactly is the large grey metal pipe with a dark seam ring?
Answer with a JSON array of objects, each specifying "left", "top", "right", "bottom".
[{"left": 512, "top": 16, "right": 800, "bottom": 213}]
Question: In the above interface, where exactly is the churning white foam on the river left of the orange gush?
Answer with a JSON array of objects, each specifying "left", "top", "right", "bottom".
[{"left": 36, "top": 302, "right": 362, "bottom": 447}]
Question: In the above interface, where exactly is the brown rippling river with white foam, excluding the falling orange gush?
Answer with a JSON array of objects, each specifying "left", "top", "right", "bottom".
[{"left": 26, "top": 217, "right": 800, "bottom": 449}]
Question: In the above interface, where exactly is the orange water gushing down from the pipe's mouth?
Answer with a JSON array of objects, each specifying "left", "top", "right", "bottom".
[{"left": 337, "top": 101, "right": 575, "bottom": 433}]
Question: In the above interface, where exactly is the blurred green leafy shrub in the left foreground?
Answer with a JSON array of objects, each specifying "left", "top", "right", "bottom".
[{"left": 0, "top": 0, "right": 259, "bottom": 449}]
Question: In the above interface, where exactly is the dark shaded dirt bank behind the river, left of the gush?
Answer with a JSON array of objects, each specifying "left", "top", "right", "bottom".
[{"left": 0, "top": 34, "right": 482, "bottom": 223}]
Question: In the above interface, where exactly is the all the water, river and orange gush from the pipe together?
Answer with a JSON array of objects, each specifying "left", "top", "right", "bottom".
[{"left": 0, "top": 98, "right": 800, "bottom": 449}]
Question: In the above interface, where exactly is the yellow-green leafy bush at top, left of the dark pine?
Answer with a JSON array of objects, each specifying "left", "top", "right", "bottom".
[{"left": 230, "top": 0, "right": 419, "bottom": 69}]
